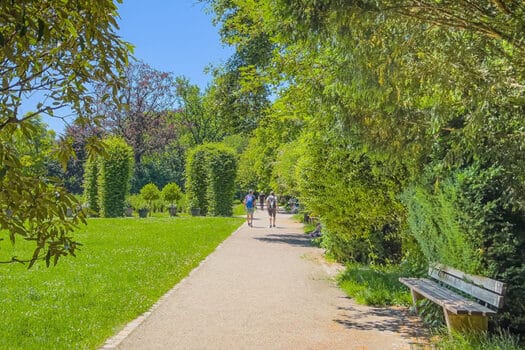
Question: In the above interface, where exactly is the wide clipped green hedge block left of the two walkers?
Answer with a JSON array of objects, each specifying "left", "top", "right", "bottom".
[{"left": 186, "top": 144, "right": 237, "bottom": 216}]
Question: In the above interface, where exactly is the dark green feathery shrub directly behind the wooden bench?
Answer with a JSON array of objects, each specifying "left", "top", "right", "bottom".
[{"left": 403, "top": 163, "right": 525, "bottom": 333}]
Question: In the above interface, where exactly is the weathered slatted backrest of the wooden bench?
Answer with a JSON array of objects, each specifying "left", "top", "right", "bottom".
[{"left": 428, "top": 265, "right": 505, "bottom": 308}]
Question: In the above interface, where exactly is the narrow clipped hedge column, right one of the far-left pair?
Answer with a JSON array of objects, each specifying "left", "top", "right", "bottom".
[{"left": 97, "top": 137, "right": 133, "bottom": 217}]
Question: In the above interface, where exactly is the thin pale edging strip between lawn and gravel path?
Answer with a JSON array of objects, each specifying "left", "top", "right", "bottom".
[{"left": 99, "top": 222, "right": 246, "bottom": 350}]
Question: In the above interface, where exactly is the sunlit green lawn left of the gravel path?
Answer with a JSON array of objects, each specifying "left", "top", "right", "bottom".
[{"left": 0, "top": 217, "right": 242, "bottom": 349}]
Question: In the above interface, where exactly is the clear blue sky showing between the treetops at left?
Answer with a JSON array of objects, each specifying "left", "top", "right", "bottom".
[{"left": 44, "top": 0, "right": 233, "bottom": 133}]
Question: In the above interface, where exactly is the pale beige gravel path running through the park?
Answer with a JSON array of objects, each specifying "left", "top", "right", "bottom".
[{"left": 103, "top": 211, "right": 423, "bottom": 350}]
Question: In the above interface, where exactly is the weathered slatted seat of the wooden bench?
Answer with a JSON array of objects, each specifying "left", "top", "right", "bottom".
[{"left": 399, "top": 278, "right": 496, "bottom": 316}]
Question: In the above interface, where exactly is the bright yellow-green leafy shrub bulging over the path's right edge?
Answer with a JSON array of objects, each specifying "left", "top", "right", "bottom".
[{"left": 297, "top": 135, "right": 404, "bottom": 263}]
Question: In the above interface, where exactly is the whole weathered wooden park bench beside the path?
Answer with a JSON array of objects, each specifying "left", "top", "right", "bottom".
[{"left": 399, "top": 264, "right": 506, "bottom": 332}]
